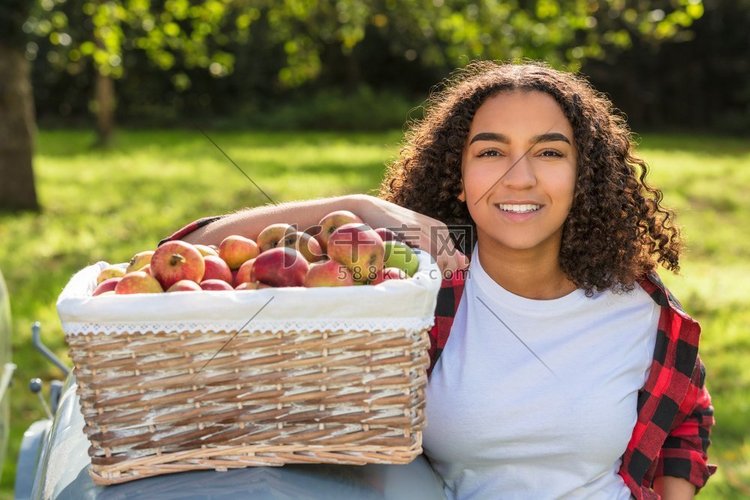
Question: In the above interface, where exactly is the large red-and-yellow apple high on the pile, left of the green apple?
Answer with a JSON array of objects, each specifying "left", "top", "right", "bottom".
[{"left": 328, "top": 223, "right": 385, "bottom": 282}]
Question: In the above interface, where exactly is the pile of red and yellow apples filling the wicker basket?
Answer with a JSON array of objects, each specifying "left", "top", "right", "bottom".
[{"left": 93, "top": 210, "right": 419, "bottom": 296}]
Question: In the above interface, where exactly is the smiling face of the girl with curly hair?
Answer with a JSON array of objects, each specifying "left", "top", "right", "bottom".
[{"left": 459, "top": 91, "right": 577, "bottom": 255}]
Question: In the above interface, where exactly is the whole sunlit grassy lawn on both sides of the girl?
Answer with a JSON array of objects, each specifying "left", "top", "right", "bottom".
[{"left": 0, "top": 130, "right": 750, "bottom": 499}]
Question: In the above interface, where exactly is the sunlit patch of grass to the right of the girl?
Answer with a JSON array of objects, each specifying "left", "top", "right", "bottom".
[{"left": 641, "top": 132, "right": 750, "bottom": 499}]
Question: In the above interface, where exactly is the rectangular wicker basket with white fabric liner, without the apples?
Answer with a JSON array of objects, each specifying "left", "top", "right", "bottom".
[{"left": 58, "top": 253, "right": 440, "bottom": 484}]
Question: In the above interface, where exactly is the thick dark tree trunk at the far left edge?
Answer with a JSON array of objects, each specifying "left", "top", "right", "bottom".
[{"left": 0, "top": 43, "right": 39, "bottom": 210}]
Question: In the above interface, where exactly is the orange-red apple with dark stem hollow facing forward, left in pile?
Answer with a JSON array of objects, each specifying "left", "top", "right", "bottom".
[{"left": 151, "top": 240, "right": 206, "bottom": 290}]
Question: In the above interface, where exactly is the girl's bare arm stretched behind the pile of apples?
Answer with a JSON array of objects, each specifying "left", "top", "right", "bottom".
[{"left": 179, "top": 194, "right": 468, "bottom": 271}]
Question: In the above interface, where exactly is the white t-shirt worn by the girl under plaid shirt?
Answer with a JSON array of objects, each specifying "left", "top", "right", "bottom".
[{"left": 423, "top": 249, "right": 660, "bottom": 500}]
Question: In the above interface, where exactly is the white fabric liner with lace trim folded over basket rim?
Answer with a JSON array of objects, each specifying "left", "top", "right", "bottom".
[{"left": 57, "top": 251, "right": 442, "bottom": 335}]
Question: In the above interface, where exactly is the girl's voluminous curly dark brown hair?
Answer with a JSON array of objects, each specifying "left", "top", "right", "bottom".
[{"left": 380, "top": 61, "right": 681, "bottom": 295}]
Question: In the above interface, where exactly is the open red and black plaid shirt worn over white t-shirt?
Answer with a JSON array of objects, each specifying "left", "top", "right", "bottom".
[{"left": 429, "top": 272, "right": 716, "bottom": 500}]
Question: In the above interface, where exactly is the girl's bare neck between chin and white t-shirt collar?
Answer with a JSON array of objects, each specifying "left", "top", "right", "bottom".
[{"left": 478, "top": 242, "right": 577, "bottom": 300}]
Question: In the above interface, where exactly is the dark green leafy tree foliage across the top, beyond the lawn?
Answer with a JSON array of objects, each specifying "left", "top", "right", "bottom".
[{"left": 16, "top": 0, "right": 750, "bottom": 134}]
